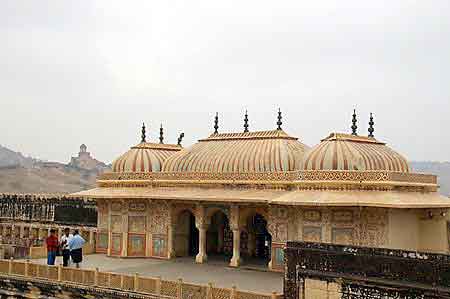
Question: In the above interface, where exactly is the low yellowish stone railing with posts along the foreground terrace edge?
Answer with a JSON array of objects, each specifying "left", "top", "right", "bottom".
[{"left": 0, "top": 259, "right": 284, "bottom": 299}]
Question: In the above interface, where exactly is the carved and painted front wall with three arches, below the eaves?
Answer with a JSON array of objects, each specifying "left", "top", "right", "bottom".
[{"left": 97, "top": 200, "right": 389, "bottom": 270}]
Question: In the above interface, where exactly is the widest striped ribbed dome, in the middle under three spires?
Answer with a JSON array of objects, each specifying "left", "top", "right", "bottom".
[{"left": 163, "top": 130, "right": 309, "bottom": 173}]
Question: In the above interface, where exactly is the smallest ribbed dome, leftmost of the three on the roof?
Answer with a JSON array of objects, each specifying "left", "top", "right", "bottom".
[{"left": 112, "top": 142, "right": 181, "bottom": 172}]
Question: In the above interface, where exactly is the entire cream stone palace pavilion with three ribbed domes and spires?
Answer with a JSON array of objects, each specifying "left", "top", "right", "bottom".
[{"left": 74, "top": 112, "right": 450, "bottom": 270}]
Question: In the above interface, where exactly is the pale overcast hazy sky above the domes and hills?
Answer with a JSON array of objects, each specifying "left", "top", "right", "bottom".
[{"left": 0, "top": 0, "right": 450, "bottom": 162}]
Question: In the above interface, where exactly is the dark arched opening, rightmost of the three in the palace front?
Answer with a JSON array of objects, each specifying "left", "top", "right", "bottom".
[{"left": 246, "top": 213, "right": 272, "bottom": 266}]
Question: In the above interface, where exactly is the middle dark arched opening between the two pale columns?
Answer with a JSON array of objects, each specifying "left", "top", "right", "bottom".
[{"left": 206, "top": 210, "right": 233, "bottom": 261}]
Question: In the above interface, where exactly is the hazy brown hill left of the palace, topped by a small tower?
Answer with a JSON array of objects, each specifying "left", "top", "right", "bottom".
[{"left": 0, "top": 145, "right": 109, "bottom": 193}]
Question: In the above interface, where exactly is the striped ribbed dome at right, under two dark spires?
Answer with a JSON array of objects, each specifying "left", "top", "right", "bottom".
[{"left": 303, "top": 133, "right": 409, "bottom": 172}]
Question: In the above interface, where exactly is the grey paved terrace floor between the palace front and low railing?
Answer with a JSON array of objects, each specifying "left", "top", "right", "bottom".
[{"left": 34, "top": 254, "right": 283, "bottom": 293}]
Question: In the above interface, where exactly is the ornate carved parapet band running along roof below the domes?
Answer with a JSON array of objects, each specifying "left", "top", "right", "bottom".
[{"left": 97, "top": 170, "right": 437, "bottom": 191}]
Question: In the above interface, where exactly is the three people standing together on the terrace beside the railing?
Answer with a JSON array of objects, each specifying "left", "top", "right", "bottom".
[{"left": 45, "top": 228, "right": 86, "bottom": 268}]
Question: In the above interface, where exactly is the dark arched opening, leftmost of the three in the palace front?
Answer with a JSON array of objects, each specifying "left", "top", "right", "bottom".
[{"left": 175, "top": 210, "right": 199, "bottom": 257}]
